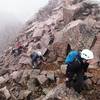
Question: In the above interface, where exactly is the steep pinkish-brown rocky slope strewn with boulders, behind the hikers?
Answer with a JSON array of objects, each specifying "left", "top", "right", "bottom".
[{"left": 0, "top": 0, "right": 100, "bottom": 100}]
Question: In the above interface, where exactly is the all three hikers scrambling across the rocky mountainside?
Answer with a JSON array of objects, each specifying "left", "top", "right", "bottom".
[{"left": 12, "top": 40, "right": 94, "bottom": 93}]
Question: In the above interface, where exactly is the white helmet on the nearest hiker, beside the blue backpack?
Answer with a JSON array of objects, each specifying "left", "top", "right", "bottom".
[{"left": 81, "top": 49, "right": 94, "bottom": 60}]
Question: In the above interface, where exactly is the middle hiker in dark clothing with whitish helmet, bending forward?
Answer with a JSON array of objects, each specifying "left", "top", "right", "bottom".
[{"left": 31, "top": 51, "right": 43, "bottom": 69}]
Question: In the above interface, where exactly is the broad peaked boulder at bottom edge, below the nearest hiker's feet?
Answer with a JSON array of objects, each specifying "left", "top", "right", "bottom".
[{"left": 43, "top": 84, "right": 85, "bottom": 100}]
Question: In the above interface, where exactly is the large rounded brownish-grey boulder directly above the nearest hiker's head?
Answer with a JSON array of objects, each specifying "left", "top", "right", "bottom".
[{"left": 63, "top": 20, "right": 95, "bottom": 50}]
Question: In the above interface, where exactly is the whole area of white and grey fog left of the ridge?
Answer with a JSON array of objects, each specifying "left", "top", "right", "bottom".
[{"left": 0, "top": 0, "right": 48, "bottom": 55}]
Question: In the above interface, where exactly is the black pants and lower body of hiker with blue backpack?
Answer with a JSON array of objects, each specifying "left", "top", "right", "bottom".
[{"left": 66, "top": 62, "right": 87, "bottom": 92}]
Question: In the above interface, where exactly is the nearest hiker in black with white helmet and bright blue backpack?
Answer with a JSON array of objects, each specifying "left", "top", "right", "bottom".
[{"left": 65, "top": 49, "right": 94, "bottom": 92}]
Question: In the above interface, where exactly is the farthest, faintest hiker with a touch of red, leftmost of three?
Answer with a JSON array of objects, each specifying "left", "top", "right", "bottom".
[{"left": 11, "top": 42, "right": 23, "bottom": 57}]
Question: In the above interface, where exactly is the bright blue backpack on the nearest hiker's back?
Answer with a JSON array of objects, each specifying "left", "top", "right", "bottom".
[{"left": 65, "top": 51, "right": 81, "bottom": 64}]
